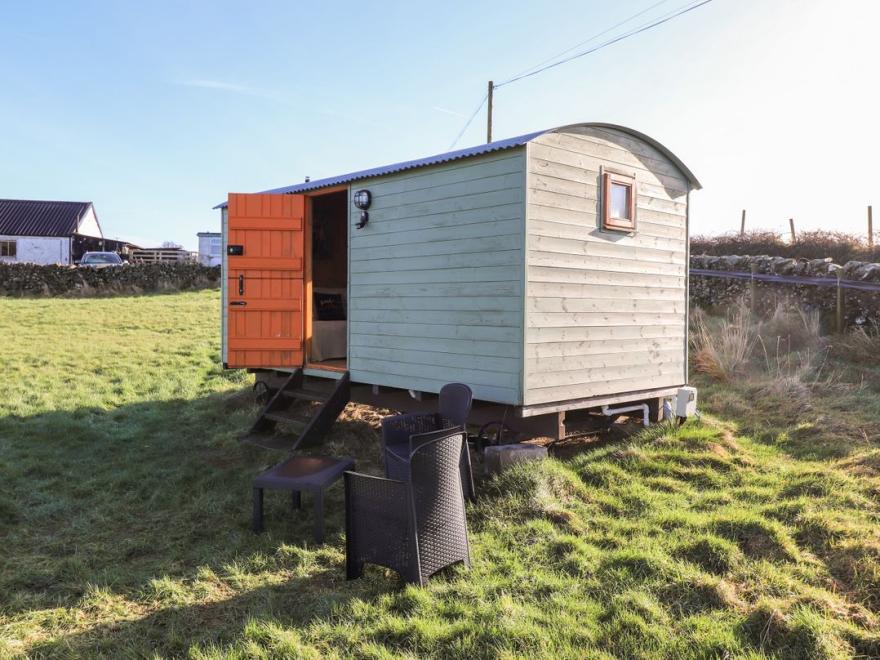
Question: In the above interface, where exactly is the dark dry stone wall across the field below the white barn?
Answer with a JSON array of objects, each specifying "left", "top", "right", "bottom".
[{"left": 0, "top": 262, "right": 220, "bottom": 297}]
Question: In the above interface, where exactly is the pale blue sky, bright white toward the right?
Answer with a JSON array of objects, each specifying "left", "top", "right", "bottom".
[{"left": 0, "top": 0, "right": 880, "bottom": 247}]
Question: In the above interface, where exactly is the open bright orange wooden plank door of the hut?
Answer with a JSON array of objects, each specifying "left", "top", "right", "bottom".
[{"left": 226, "top": 193, "right": 305, "bottom": 368}]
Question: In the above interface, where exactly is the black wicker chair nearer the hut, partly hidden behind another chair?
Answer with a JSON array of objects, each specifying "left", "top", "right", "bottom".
[{"left": 382, "top": 383, "right": 476, "bottom": 501}]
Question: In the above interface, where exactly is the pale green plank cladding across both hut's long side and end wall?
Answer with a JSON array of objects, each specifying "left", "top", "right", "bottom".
[{"left": 340, "top": 128, "right": 689, "bottom": 405}]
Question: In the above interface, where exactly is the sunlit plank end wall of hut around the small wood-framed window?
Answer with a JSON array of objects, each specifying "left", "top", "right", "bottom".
[{"left": 523, "top": 126, "right": 689, "bottom": 405}]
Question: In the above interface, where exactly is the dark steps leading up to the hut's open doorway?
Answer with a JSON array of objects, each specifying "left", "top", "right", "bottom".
[{"left": 242, "top": 369, "right": 351, "bottom": 451}]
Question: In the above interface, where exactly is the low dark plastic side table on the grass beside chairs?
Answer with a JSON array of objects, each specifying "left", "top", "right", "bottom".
[{"left": 251, "top": 456, "right": 354, "bottom": 543}]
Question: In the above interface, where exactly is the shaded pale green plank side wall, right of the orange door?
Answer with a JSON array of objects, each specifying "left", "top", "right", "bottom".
[{"left": 348, "top": 148, "right": 525, "bottom": 404}]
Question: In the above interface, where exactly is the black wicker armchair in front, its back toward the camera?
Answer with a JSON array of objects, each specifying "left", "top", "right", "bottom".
[{"left": 345, "top": 429, "right": 470, "bottom": 585}]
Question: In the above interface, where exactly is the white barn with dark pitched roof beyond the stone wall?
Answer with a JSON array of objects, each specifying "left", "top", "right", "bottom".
[{"left": 0, "top": 199, "right": 119, "bottom": 265}]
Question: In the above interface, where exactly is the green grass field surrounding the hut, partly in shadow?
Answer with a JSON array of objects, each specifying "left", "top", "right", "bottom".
[{"left": 0, "top": 292, "right": 880, "bottom": 658}]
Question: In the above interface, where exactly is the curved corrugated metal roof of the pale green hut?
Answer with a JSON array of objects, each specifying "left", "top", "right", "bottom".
[{"left": 213, "top": 122, "right": 703, "bottom": 209}]
